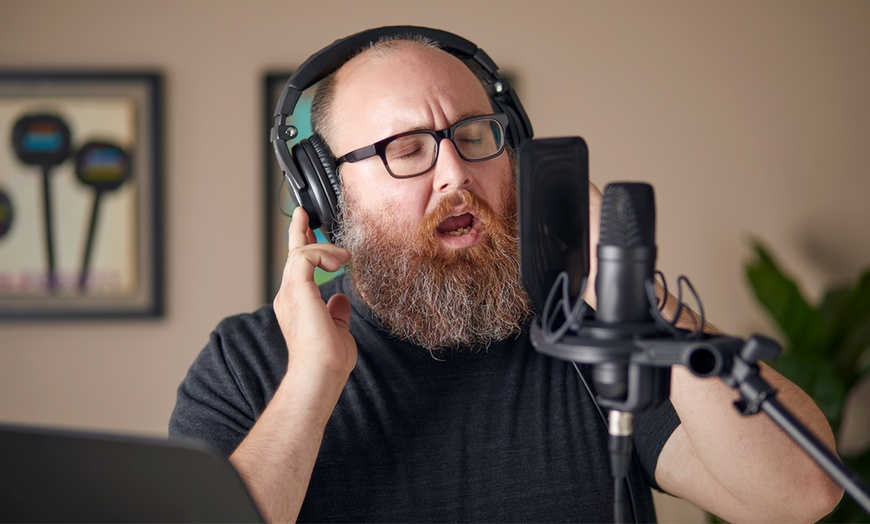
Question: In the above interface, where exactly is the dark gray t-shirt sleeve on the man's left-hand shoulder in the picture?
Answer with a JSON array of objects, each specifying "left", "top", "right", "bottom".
[{"left": 169, "top": 307, "right": 287, "bottom": 456}]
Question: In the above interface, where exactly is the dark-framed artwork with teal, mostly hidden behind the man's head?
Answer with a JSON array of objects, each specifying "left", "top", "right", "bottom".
[{"left": 261, "top": 71, "right": 341, "bottom": 303}]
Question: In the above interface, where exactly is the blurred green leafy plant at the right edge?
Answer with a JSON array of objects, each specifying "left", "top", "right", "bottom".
[{"left": 745, "top": 239, "right": 870, "bottom": 522}]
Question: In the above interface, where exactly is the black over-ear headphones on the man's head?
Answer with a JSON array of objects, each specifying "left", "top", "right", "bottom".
[{"left": 269, "top": 26, "right": 533, "bottom": 240}]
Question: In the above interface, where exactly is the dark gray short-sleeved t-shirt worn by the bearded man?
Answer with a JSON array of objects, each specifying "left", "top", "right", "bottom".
[{"left": 169, "top": 277, "right": 679, "bottom": 522}]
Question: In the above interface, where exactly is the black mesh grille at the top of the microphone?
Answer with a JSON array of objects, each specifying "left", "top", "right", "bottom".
[{"left": 599, "top": 182, "right": 656, "bottom": 247}]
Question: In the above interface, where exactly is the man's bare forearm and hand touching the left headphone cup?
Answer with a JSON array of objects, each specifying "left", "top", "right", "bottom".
[{"left": 230, "top": 208, "right": 357, "bottom": 521}]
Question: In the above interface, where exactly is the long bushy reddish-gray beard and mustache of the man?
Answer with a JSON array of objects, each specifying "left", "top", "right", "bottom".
[{"left": 337, "top": 168, "right": 531, "bottom": 351}]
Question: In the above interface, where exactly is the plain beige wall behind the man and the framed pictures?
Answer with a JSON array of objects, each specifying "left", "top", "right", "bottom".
[{"left": 0, "top": 0, "right": 870, "bottom": 521}]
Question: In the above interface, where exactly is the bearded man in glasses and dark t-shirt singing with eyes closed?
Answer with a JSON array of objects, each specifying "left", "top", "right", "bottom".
[{"left": 170, "top": 29, "right": 842, "bottom": 522}]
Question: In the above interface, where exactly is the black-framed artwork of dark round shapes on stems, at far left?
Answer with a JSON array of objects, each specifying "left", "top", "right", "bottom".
[{"left": 0, "top": 71, "right": 163, "bottom": 320}]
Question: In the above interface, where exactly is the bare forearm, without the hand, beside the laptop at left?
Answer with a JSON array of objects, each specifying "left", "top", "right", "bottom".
[{"left": 230, "top": 364, "right": 347, "bottom": 522}]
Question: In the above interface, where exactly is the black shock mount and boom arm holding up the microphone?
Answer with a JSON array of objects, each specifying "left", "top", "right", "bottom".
[{"left": 530, "top": 319, "right": 870, "bottom": 522}]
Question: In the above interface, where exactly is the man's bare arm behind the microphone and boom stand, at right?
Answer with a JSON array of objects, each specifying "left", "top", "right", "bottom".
[{"left": 584, "top": 184, "right": 843, "bottom": 522}]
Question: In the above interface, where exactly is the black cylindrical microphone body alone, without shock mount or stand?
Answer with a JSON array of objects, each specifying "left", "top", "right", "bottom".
[{"left": 592, "top": 182, "right": 656, "bottom": 401}]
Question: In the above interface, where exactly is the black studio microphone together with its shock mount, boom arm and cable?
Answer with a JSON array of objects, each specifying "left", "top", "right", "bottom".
[{"left": 529, "top": 183, "right": 870, "bottom": 524}]
